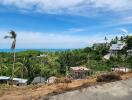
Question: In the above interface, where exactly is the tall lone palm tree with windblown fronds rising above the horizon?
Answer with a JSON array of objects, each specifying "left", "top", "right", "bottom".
[{"left": 4, "top": 30, "right": 17, "bottom": 79}]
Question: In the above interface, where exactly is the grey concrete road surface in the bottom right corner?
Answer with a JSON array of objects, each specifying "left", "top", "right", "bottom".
[{"left": 46, "top": 79, "right": 132, "bottom": 100}]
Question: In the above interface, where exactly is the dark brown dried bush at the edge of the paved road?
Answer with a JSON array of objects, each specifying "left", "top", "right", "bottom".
[{"left": 96, "top": 73, "right": 121, "bottom": 82}]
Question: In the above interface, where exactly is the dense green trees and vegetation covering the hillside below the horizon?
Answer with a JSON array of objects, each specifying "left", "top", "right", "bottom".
[{"left": 0, "top": 36, "right": 132, "bottom": 80}]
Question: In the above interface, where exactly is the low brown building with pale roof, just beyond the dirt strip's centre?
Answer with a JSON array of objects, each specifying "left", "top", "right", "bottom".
[{"left": 70, "top": 67, "right": 90, "bottom": 79}]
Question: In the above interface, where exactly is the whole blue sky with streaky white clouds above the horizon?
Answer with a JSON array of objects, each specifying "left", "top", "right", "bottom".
[{"left": 0, "top": 0, "right": 132, "bottom": 49}]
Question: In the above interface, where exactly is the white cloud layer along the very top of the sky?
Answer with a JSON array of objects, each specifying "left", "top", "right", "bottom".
[{"left": 0, "top": 0, "right": 132, "bottom": 15}]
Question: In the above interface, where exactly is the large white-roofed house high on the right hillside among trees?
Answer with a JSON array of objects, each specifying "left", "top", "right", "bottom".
[{"left": 110, "top": 41, "right": 126, "bottom": 56}]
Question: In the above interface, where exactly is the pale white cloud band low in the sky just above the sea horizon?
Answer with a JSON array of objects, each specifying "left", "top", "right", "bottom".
[{"left": 0, "top": 31, "right": 115, "bottom": 48}]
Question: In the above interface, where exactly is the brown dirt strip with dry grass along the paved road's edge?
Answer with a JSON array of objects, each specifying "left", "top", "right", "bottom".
[{"left": 0, "top": 72, "right": 132, "bottom": 100}]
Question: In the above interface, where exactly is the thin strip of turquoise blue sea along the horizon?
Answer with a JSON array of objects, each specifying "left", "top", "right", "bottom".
[{"left": 0, "top": 49, "right": 73, "bottom": 52}]
